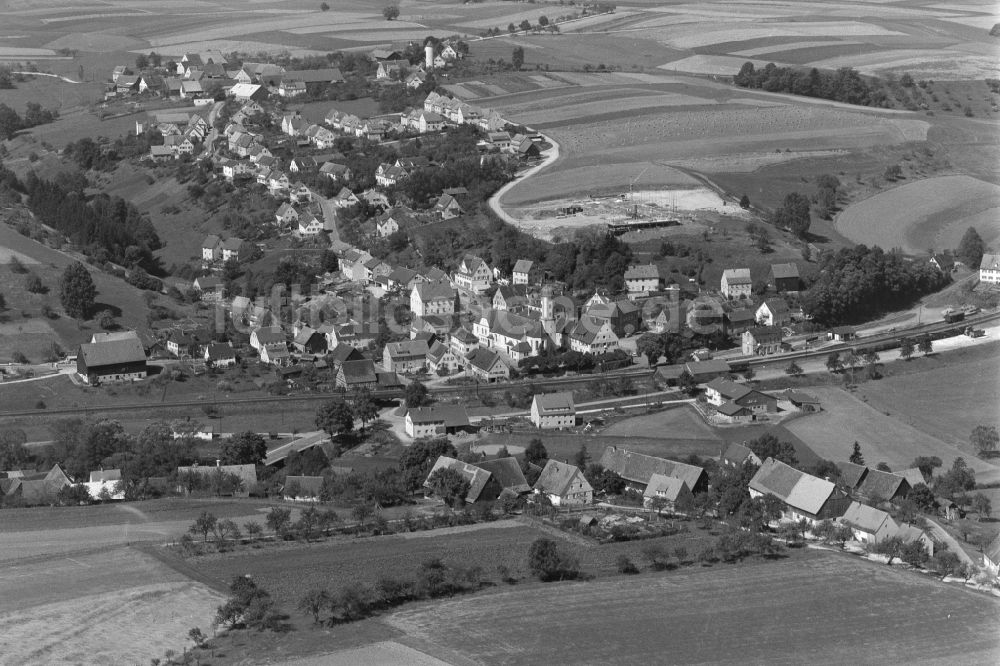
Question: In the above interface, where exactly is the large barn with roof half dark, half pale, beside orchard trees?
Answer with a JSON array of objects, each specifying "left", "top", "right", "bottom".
[{"left": 749, "top": 458, "right": 851, "bottom": 525}]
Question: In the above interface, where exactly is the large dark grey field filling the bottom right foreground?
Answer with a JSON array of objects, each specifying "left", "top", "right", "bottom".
[{"left": 385, "top": 552, "right": 1000, "bottom": 664}]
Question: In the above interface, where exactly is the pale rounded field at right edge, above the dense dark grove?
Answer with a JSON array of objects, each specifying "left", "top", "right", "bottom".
[{"left": 835, "top": 176, "right": 1000, "bottom": 254}]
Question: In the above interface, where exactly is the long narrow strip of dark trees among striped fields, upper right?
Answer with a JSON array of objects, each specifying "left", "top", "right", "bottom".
[{"left": 733, "top": 62, "right": 891, "bottom": 107}]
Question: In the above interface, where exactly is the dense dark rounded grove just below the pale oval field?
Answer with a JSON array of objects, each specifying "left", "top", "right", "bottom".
[{"left": 802, "top": 245, "right": 951, "bottom": 325}]
